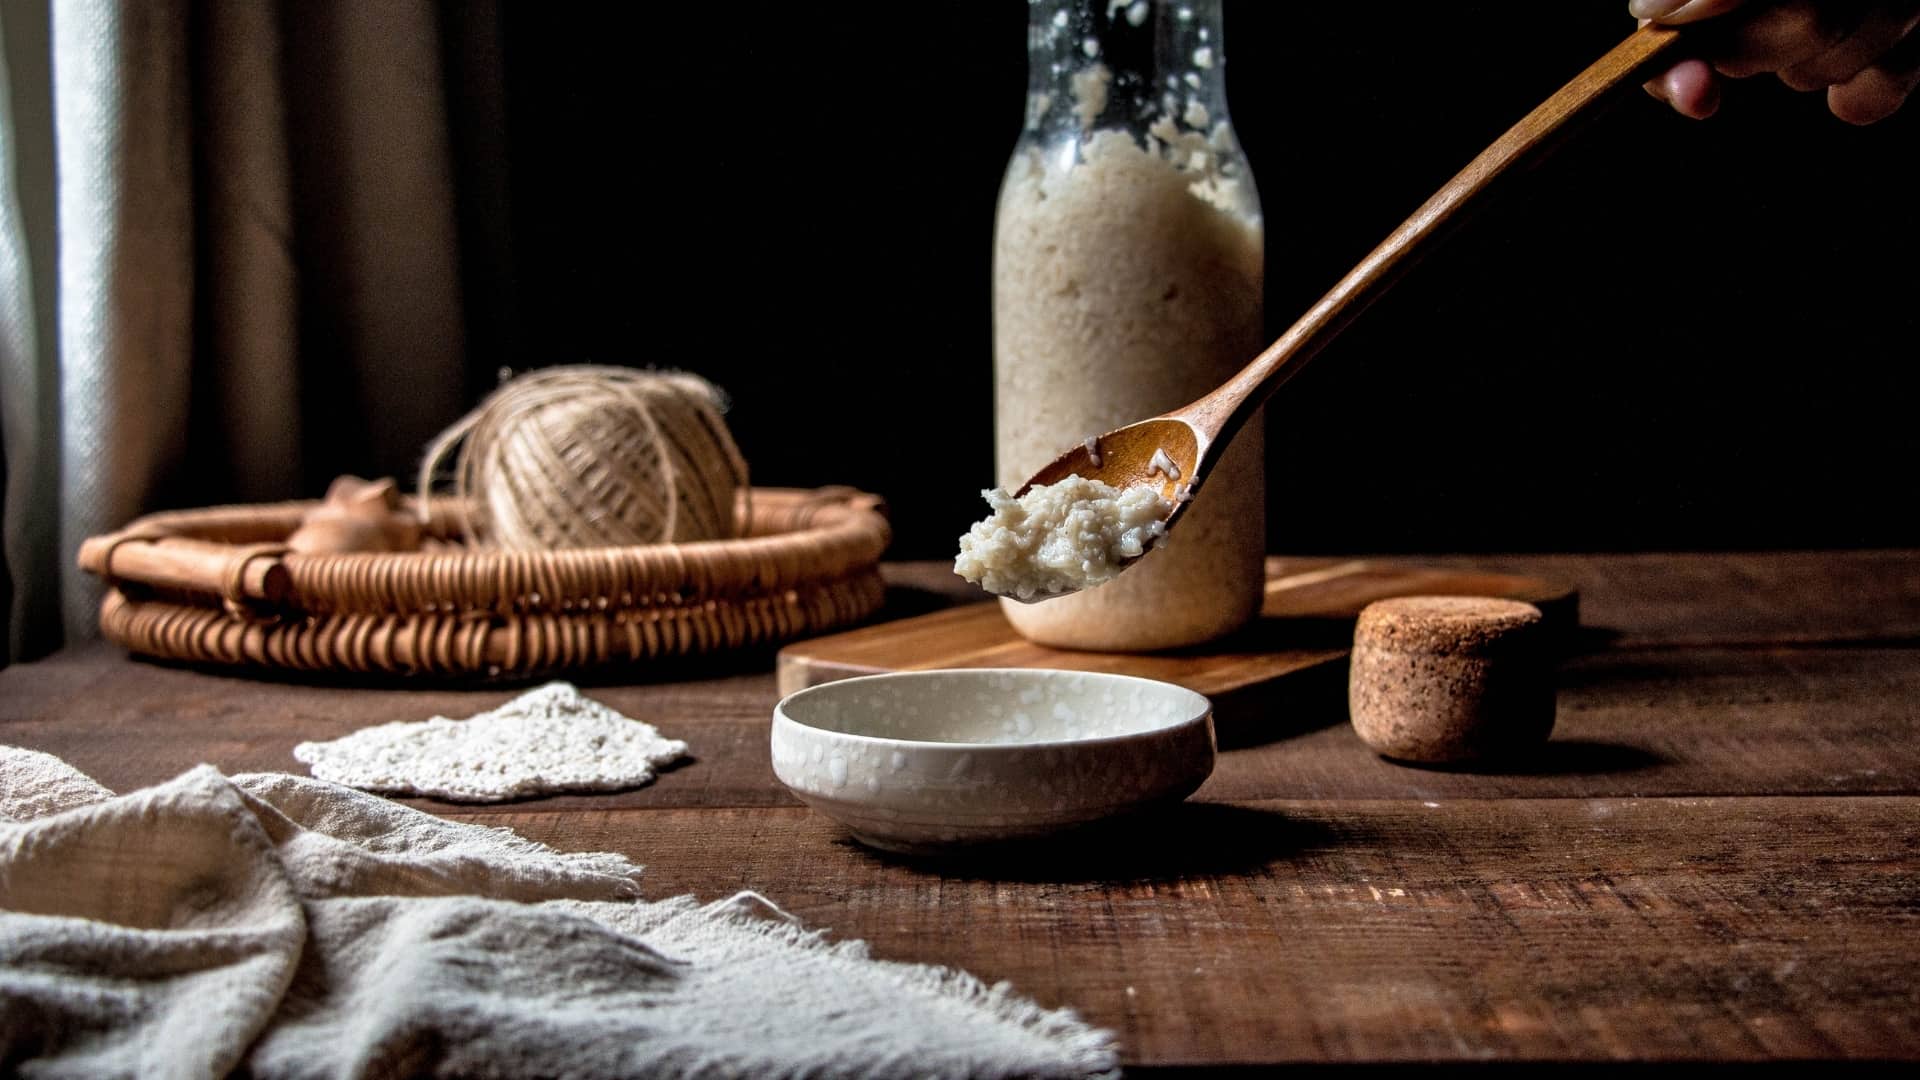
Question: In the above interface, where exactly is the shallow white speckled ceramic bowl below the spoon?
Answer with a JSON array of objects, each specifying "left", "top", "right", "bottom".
[{"left": 772, "top": 669, "right": 1213, "bottom": 855}]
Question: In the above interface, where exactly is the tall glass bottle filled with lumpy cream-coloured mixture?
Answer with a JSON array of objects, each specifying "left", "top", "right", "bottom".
[{"left": 993, "top": 0, "right": 1265, "bottom": 651}]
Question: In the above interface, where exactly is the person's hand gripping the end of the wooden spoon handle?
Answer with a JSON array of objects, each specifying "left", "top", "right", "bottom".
[{"left": 1626, "top": 0, "right": 1920, "bottom": 123}]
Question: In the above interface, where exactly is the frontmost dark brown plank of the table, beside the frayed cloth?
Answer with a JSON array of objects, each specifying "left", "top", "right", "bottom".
[{"left": 460, "top": 798, "right": 1920, "bottom": 1065}]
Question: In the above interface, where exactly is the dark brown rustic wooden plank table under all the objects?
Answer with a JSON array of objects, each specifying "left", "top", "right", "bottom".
[{"left": 0, "top": 552, "right": 1920, "bottom": 1067}]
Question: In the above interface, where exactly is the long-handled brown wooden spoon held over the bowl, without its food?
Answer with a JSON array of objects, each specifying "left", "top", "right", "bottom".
[{"left": 1014, "top": 25, "right": 1680, "bottom": 541}]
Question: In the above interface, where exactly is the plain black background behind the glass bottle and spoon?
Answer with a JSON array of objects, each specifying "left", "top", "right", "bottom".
[{"left": 483, "top": 0, "right": 1920, "bottom": 557}]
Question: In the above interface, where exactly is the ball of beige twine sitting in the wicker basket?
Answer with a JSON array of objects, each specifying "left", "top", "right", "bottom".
[{"left": 420, "top": 365, "right": 747, "bottom": 552}]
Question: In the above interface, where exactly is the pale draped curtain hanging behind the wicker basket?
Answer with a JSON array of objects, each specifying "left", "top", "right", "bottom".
[{"left": 0, "top": 0, "right": 499, "bottom": 663}]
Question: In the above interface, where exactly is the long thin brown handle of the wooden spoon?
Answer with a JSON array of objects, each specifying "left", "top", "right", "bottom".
[{"left": 1169, "top": 23, "right": 1680, "bottom": 447}]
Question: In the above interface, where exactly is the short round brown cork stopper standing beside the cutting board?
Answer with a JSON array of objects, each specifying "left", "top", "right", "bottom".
[{"left": 1348, "top": 596, "right": 1555, "bottom": 763}]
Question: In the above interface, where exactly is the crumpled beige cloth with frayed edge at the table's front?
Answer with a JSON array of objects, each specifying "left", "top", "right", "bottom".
[{"left": 0, "top": 748, "right": 1116, "bottom": 1078}]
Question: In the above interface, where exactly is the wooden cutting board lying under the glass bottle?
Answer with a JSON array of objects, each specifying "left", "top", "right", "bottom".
[{"left": 778, "top": 557, "right": 1578, "bottom": 711}]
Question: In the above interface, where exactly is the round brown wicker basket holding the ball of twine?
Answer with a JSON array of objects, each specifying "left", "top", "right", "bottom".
[{"left": 79, "top": 488, "right": 889, "bottom": 678}]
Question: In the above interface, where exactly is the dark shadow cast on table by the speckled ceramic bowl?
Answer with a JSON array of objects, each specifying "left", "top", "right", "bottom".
[{"left": 864, "top": 803, "right": 1352, "bottom": 884}]
